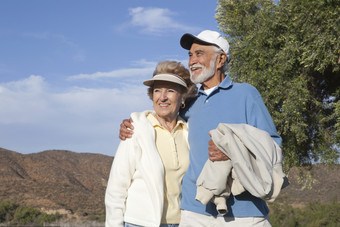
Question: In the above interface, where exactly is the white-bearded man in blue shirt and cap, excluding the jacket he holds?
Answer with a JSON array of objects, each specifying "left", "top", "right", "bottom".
[{"left": 120, "top": 30, "right": 281, "bottom": 227}]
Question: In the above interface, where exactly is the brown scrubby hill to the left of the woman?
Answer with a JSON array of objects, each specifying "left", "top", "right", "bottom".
[{"left": 0, "top": 148, "right": 113, "bottom": 222}]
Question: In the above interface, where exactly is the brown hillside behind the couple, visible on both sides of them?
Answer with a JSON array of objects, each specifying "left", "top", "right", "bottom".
[{"left": 0, "top": 148, "right": 340, "bottom": 223}]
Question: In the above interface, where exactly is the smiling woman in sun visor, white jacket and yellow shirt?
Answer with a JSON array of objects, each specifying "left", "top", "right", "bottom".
[{"left": 105, "top": 61, "right": 196, "bottom": 227}]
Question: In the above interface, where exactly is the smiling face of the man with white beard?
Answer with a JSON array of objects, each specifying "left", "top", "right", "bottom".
[{"left": 189, "top": 43, "right": 217, "bottom": 84}]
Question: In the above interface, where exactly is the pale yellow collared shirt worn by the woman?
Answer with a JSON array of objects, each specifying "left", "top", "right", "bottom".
[{"left": 147, "top": 114, "right": 189, "bottom": 224}]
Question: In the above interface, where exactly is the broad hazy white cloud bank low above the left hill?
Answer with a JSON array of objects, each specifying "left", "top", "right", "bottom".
[{"left": 0, "top": 73, "right": 152, "bottom": 155}]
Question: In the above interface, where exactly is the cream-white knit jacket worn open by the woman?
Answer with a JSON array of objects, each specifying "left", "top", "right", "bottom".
[{"left": 105, "top": 111, "right": 188, "bottom": 227}]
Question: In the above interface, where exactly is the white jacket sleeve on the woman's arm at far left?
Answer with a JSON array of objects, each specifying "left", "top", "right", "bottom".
[{"left": 105, "top": 137, "right": 141, "bottom": 227}]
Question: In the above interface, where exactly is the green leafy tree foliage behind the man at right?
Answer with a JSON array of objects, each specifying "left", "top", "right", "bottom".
[{"left": 216, "top": 0, "right": 340, "bottom": 167}]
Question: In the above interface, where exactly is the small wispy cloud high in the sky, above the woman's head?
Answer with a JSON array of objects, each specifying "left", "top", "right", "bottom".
[{"left": 123, "top": 7, "right": 197, "bottom": 35}]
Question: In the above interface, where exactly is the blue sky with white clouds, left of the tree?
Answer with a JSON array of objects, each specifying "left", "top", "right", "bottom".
[{"left": 0, "top": 0, "right": 218, "bottom": 156}]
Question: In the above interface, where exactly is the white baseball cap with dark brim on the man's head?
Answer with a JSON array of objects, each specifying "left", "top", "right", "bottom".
[{"left": 180, "top": 30, "right": 230, "bottom": 62}]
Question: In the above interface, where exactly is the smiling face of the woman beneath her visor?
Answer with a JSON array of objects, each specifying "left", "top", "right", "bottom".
[{"left": 153, "top": 81, "right": 184, "bottom": 120}]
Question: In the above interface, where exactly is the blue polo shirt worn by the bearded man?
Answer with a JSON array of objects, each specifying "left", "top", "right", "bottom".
[{"left": 180, "top": 76, "right": 281, "bottom": 217}]
